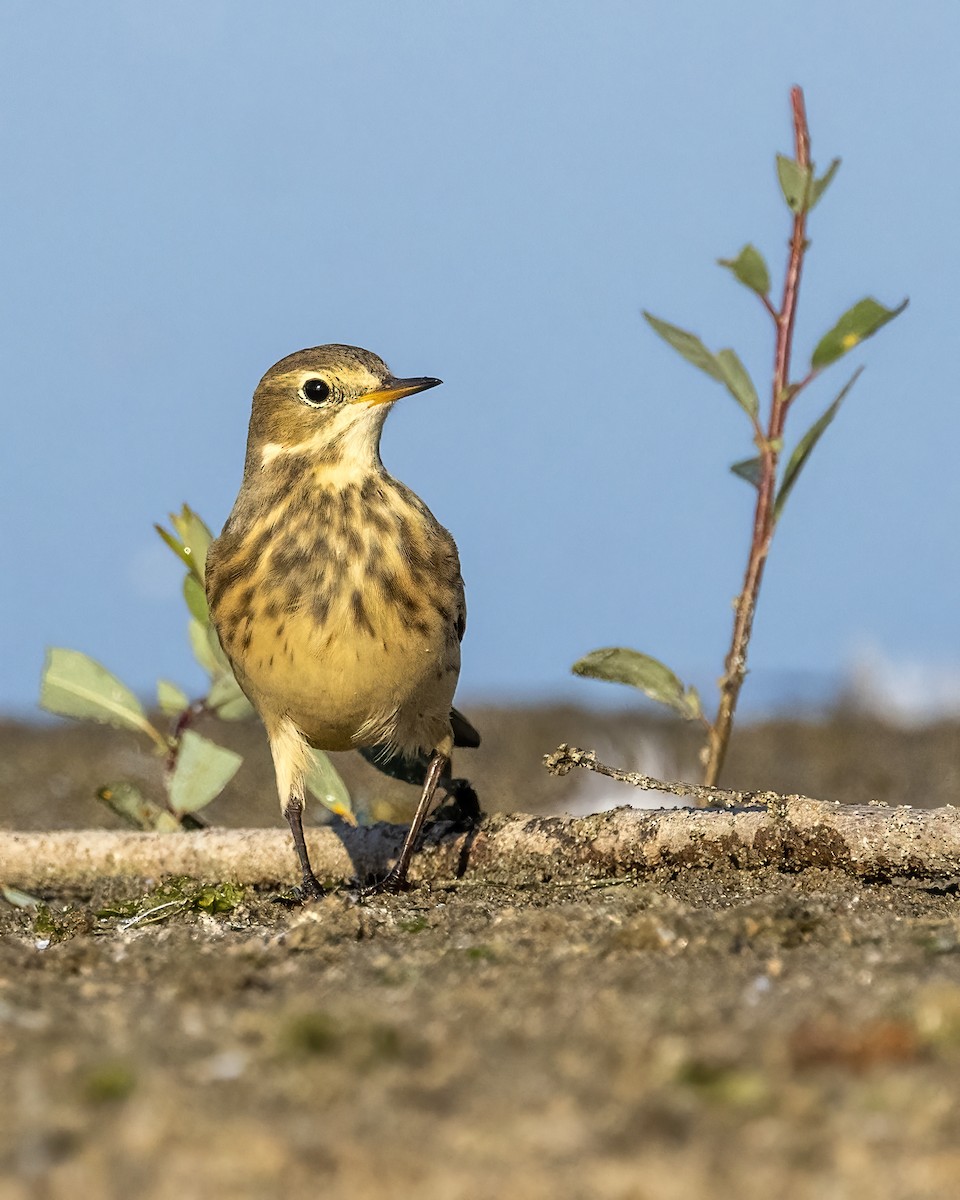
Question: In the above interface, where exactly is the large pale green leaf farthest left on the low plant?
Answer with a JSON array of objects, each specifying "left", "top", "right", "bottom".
[{"left": 40, "top": 646, "right": 166, "bottom": 746}]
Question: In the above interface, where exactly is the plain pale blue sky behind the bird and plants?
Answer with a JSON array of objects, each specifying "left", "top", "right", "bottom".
[{"left": 0, "top": 0, "right": 960, "bottom": 712}]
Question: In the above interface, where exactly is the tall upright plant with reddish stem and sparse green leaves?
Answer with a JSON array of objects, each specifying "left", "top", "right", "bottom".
[{"left": 572, "top": 88, "right": 907, "bottom": 786}]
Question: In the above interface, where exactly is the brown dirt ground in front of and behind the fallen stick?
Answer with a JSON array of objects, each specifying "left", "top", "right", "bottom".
[{"left": 0, "top": 709, "right": 960, "bottom": 1200}]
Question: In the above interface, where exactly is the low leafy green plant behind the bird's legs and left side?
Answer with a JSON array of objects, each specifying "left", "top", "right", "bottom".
[{"left": 40, "top": 504, "right": 354, "bottom": 832}]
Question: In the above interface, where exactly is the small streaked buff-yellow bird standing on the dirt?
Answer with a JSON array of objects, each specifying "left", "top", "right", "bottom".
[{"left": 205, "top": 344, "right": 480, "bottom": 900}]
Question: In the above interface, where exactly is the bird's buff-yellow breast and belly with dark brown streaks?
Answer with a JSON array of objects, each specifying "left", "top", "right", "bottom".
[{"left": 208, "top": 468, "right": 462, "bottom": 749}]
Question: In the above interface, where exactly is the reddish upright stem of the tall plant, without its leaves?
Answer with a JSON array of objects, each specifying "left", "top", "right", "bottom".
[{"left": 703, "top": 88, "right": 810, "bottom": 787}]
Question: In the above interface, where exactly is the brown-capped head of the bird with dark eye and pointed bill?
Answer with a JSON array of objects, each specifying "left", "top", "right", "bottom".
[{"left": 246, "top": 346, "right": 440, "bottom": 473}]
